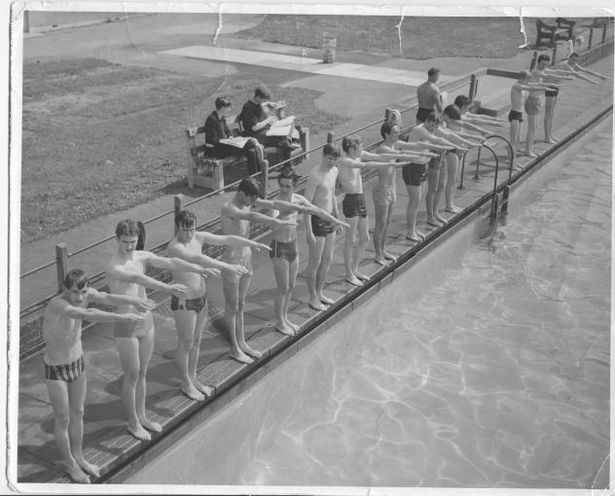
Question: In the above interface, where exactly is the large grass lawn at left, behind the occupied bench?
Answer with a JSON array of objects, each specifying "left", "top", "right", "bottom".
[{"left": 21, "top": 58, "right": 344, "bottom": 242}]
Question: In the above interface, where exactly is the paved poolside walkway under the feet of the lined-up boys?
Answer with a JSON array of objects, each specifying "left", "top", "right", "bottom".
[{"left": 18, "top": 51, "right": 613, "bottom": 482}]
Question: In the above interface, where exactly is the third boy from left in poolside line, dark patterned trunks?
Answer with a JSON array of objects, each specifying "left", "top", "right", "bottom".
[{"left": 167, "top": 210, "right": 268, "bottom": 401}]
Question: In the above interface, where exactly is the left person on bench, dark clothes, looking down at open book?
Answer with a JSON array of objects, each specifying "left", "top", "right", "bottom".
[{"left": 205, "top": 96, "right": 264, "bottom": 175}]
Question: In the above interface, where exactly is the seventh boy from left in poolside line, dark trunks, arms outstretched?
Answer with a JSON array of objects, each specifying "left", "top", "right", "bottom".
[{"left": 339, "top": 136, "right": 408, "bottom": 286}]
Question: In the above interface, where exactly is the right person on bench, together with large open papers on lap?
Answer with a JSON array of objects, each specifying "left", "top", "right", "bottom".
[{"left": 237, "top": 86, "right": 296, "bottom": 161}]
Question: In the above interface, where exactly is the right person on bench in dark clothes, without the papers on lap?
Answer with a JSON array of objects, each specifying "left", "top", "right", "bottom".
[{"left": 237, "top": 86, "right": 292, "bottom": 160}]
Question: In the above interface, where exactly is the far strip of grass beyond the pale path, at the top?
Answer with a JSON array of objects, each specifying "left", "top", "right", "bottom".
[{"left": 235, "top": 15, "right": 536, "bottom": 59}]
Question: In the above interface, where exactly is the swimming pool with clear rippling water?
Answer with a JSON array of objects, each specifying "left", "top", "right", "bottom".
[{"left": 126, "top": 119, "right": 612, "bottom": 488}]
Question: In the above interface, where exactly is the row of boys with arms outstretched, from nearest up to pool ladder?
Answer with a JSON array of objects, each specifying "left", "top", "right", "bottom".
[{"left": 43, "top": 99, "right": 512, "bottom": 483}]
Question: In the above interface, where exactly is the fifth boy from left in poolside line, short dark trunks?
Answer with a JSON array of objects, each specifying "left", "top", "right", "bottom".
[{"left": 269, "top": 165, "right": 348, "bottom": 336}]
